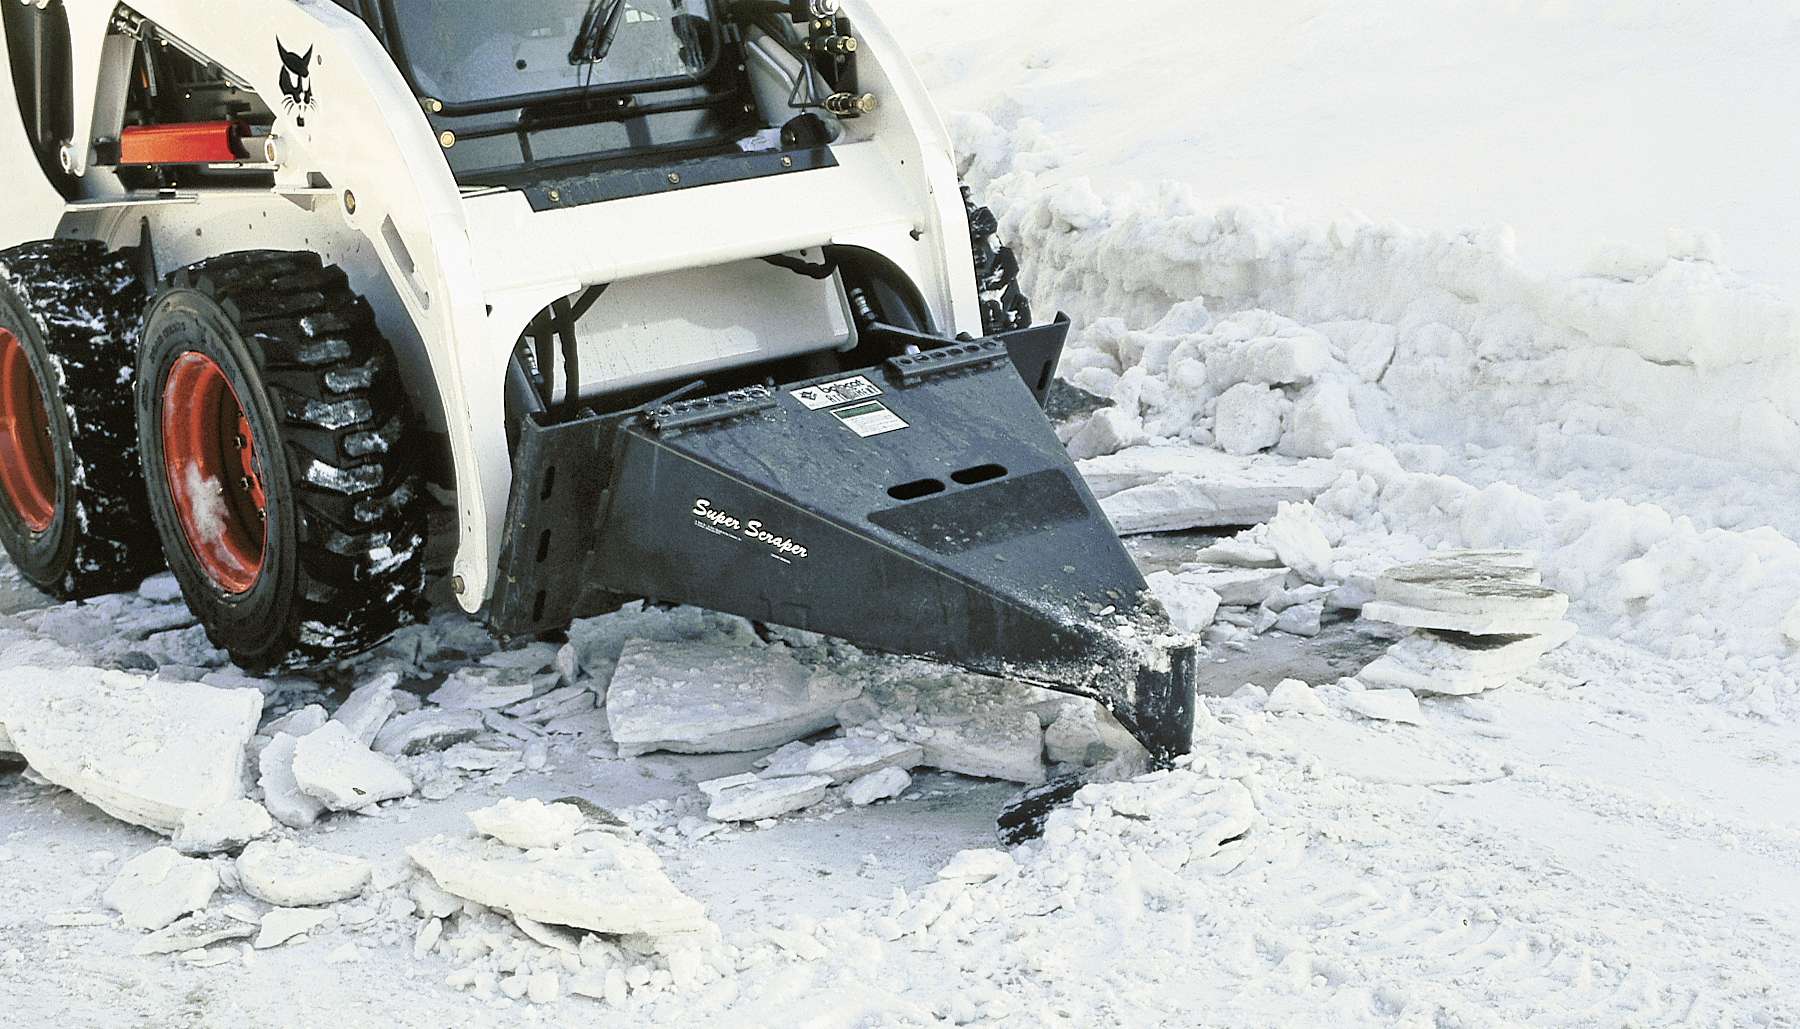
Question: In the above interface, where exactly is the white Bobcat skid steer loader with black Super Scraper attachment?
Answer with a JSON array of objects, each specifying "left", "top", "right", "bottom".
[{"left": 0, "top": 0, "right": 1193, "bottom": 757}]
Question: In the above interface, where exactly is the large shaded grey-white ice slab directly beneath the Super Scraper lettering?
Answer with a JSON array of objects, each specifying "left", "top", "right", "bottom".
[{"left": 607, "top": 640, "right": 862, "bottom": 757}]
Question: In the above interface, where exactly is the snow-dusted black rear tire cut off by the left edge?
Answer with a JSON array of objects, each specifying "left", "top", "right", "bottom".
[{"left": 0, "top": 239, "right": 162, "bottom": 601}]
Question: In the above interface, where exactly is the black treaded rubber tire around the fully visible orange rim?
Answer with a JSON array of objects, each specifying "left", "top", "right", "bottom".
[{"left": 137, "top": 250, "right": 425, "bottom": 673}]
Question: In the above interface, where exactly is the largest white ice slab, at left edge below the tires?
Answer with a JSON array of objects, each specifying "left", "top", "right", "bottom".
[{"left": 0, "top": 667, "right": 263, "bottom": 833}]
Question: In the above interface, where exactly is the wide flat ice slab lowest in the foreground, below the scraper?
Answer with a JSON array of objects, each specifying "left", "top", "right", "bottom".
[{"left": 407, "top": 831, "right": 711, "bottom": 939}]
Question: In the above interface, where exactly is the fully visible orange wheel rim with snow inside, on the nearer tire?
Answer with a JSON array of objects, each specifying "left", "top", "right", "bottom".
[{"left": 162, "top": 351, "right": 268, "bottom": 594}]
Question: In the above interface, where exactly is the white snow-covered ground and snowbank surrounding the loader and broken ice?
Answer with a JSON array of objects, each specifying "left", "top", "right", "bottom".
[{"left": 0, "top": 0, "right": 1800, "bottom": 1027}]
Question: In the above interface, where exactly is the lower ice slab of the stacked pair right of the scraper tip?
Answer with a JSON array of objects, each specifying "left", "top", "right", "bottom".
[{"left": 1357, "top": 622, "right": 1577, "bottom": 694}]
